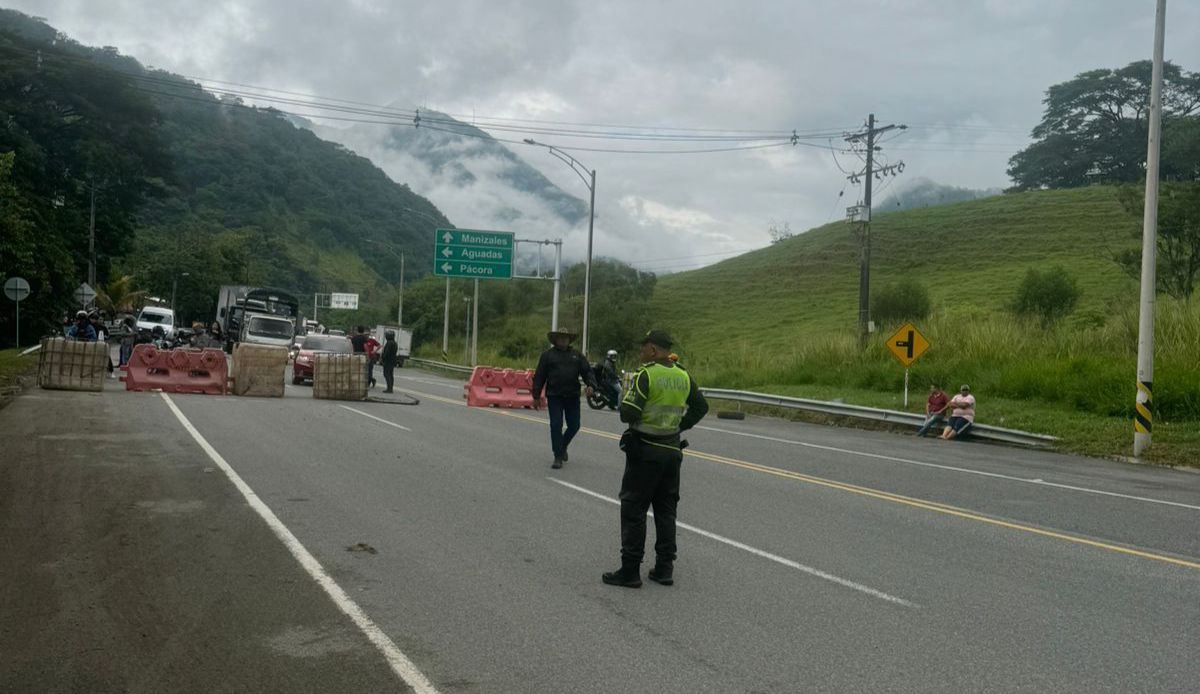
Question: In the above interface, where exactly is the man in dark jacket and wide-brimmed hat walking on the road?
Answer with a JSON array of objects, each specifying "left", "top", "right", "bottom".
[{"left": 533, "top": 330, "right": 596, "bottom": 468}]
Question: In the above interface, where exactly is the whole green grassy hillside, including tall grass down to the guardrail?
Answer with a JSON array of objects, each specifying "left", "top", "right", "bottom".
[{"left": 652, "top": 187, "right": 1200, "bottom": 465}]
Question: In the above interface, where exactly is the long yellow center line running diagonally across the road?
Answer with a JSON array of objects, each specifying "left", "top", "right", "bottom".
[{"left": 400, "top": 390, "right": 1200, "bottom": 570}]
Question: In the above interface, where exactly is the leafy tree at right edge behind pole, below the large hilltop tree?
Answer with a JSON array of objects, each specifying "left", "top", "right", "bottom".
[{"left": 1112, "top": 183, "right": 1200, "bottom": 300}]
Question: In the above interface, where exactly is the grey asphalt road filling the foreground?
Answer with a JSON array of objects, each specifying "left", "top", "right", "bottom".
[{"left": 0, "top": 370, "right": 1200, "bottom": 693}]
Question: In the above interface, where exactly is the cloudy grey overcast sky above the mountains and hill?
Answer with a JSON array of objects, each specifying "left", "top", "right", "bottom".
[{"left": 11, "top": 0, "right": 1200, "bottom": 270}]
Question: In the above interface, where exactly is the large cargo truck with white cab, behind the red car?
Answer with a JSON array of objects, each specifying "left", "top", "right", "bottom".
[{"left": 216, "top": 285, "right": 300, "bottom": 352}]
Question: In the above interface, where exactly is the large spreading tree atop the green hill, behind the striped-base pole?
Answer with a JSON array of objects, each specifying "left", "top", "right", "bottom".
[{"left": 1008, "top": 60, "right": 1200, "bottom": 190}]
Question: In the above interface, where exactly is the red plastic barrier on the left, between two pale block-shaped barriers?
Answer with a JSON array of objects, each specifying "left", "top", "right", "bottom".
[{"left": 121, "top": 345, "right": 229, "bottom": 395}]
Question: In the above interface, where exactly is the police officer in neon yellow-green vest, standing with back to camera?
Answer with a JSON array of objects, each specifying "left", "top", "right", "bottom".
[{"left": 601, "top": 330, "right": 708, "bottom": 588}]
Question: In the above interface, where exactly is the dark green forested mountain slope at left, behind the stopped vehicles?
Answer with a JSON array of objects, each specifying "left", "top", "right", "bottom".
[{"left": 0, "top": 11, "right": 449, "bottom": 335}]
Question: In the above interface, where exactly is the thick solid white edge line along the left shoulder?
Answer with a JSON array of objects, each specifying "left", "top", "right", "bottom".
[{"left": 161, "top": 393, "right": 438, "bottom": 694}]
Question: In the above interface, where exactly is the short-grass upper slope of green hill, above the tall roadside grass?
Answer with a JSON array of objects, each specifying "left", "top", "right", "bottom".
[{"left": 653, "top": 186, "right": 1138, "bottom": 354}]
